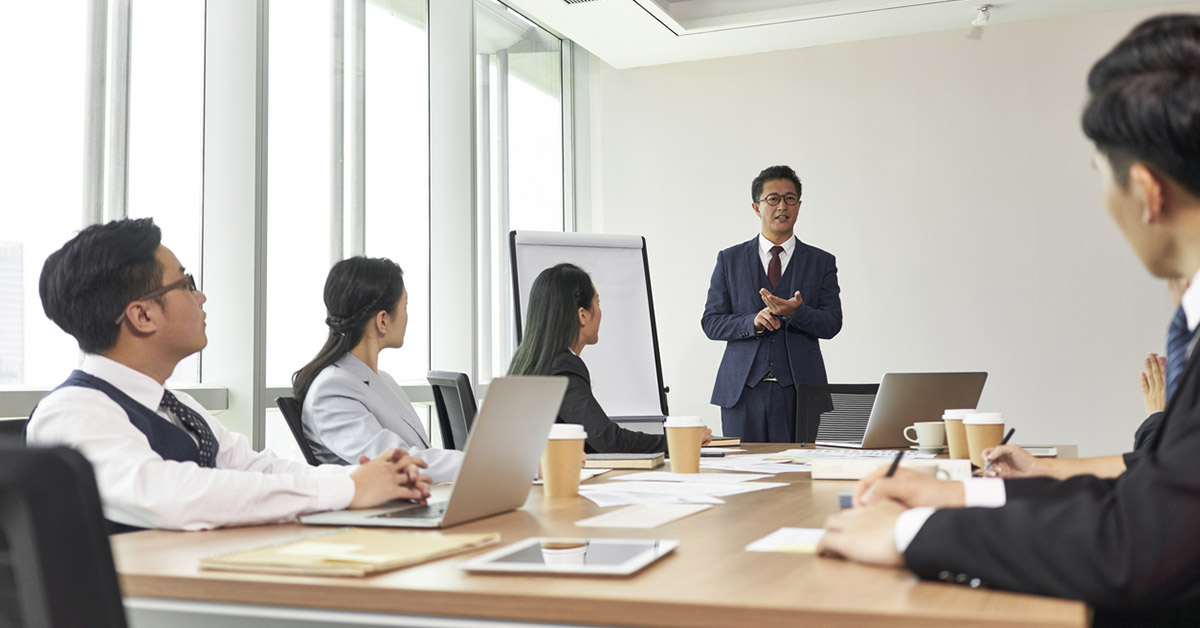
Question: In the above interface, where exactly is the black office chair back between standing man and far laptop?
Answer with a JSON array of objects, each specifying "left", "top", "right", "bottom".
[{"left": 796, "top": 384, "right": 880, "bottom": 443}]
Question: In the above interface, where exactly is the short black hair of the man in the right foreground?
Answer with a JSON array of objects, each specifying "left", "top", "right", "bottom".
[{"left": 1084, "top": 14, "right": 1200, "bottom": 197}]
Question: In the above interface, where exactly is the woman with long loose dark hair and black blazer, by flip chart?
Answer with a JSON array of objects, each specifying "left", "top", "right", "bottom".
[{"left": 509, "top": 264, "right": 712, "bottom": 453}]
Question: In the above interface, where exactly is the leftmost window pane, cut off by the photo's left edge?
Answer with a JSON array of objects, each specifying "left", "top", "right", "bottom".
[{"left": 0, "top": 2, "right": 88, "bottom": 385}]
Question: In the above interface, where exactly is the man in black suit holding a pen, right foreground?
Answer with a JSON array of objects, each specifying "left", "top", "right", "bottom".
[{"left": 821, "top": 16, "right": 1200, "bottom": 626}]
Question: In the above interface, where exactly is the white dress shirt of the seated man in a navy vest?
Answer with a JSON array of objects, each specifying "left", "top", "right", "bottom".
[{"left": 26, "top": 354, "right": 355, "bottom": 530}]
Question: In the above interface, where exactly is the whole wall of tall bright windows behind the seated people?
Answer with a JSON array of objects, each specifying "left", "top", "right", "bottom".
[{"left": 0, "top": 0, "right": 566, "bottom": 449}]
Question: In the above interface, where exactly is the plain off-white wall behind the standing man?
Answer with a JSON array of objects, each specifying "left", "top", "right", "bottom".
[{"left": 580, "top": 2, "right": 1200, "bottom": 455}]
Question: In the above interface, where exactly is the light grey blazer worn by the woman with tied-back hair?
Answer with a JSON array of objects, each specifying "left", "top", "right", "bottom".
[{"left": 300, "top": 353, "right": 462, "bottom": 483}]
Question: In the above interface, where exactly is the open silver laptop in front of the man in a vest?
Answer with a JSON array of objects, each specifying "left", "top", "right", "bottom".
[{"left": 300, "top": 377, "right": 566, "bottom": 527}]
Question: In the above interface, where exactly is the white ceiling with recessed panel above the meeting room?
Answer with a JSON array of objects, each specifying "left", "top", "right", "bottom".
[{"left": 505, "top": 0, "right": 1185, "bottom": 68}]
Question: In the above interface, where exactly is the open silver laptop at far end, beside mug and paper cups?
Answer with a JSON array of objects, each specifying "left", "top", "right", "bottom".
[{"left": 815, "top": 372, "right": 988, "bottom": 449}]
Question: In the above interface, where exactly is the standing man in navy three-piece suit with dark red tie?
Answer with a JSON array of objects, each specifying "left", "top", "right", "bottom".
[{"left": 700, "top": 166, "right": 841, "bottom": 443}]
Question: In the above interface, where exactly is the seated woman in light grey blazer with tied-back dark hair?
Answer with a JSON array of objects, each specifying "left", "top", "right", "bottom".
[{"left": 292, "top": 257, "right": 462, "bottom": 482}]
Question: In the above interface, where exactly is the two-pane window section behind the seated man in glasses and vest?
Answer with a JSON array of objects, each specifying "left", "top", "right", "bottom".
[{"left": 0, "top": 0, "right": 204, "bottom": 387}]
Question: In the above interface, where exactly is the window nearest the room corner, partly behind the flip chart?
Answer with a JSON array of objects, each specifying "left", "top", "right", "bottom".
[{"left": 475, "top": 0, "right": 564, "bottom": 382}]
